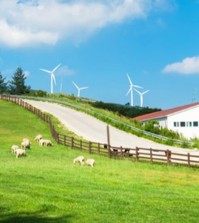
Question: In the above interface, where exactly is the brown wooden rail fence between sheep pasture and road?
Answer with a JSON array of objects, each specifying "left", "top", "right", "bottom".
[{"left": 0, "top": 95, "right": 199, "bottom": 167}]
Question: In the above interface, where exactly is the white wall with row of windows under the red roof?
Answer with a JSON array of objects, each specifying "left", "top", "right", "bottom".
[{"left": 167, "top": 106, "right": 199, "bottom": 138}]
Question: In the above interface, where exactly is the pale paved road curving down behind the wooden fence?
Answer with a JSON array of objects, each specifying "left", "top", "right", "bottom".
[{"left": 25, "top": 100, "right": 199, "bottom": 155}]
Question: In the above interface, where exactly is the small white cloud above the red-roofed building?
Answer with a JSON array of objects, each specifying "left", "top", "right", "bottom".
[{"left": 163, "top": 56, "right": 199, "bottom": 74}]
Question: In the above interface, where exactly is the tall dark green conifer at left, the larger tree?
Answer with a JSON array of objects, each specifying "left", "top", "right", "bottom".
[{"left": 9, "top": 67, "right": 30, "bottom": 95}]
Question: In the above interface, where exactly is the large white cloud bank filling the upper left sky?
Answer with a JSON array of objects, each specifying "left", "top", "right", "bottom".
[{"left": 0, "top": 0, "right": 173, "bottom": 47}]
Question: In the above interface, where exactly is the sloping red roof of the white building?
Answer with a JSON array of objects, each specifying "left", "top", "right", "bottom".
[{"left": 134, "top": 102, "right": 199, "bottom": 121}]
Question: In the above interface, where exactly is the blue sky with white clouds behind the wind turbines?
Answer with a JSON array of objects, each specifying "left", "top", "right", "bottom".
[{"left": 0, "top": 0, "right": 199, "bottom": 109}]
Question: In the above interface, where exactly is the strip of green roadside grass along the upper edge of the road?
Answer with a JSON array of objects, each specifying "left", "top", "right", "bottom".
[{"left": 26, "top": 94, "right": 193, "bottom": 148}]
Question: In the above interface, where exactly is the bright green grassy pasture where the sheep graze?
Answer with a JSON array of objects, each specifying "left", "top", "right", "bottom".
[{"left": 0, "top": 101, "right": 199, "bottom": 223}]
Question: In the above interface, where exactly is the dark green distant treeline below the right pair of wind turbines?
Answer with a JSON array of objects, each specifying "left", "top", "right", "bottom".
[{"left": 90, "top": 101, "right": 161, "bottom": 118}]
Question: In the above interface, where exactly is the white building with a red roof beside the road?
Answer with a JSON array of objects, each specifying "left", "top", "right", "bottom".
[{"left": 134, "top": 102, "right": 199, "bottom": 139}]
